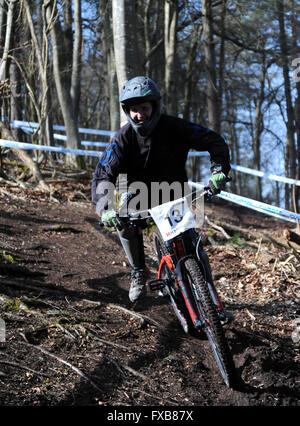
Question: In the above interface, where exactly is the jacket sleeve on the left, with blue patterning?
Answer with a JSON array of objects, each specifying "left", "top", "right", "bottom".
[{"left": 92, "top": 136, "right": 123, "bottom": 216}]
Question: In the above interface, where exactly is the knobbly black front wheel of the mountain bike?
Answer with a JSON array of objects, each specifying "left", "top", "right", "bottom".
[{"left": 185, "top": 258, "right": 236, "bottom": 387}]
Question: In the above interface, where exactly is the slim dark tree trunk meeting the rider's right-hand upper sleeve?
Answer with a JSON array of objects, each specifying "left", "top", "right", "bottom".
[{"left": 202, "top": 0, "right": 220, "bottom": 132}]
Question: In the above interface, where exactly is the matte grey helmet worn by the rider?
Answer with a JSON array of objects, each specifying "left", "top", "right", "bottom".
[{"left": 120, "top": 77, "right": 161, "bottom": 137}]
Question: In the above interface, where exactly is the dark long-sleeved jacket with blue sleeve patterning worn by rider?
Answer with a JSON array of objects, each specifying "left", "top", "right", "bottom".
[{"left": 92, "top": 114, "right": 230, "bottom": 210}]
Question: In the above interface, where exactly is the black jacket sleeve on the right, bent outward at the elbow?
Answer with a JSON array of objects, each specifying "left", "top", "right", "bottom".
[{"left": 184, "top": 121, "right": 231, "bottom": 175}]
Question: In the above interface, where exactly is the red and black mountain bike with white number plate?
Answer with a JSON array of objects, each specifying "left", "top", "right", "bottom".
[{"left": 112, "top": 188, "right": 236, "bottom": 387}]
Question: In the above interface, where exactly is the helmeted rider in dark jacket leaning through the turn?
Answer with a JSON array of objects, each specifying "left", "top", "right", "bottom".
[{"left": 92, "top": 76, "right": 230, "bottom": 310}]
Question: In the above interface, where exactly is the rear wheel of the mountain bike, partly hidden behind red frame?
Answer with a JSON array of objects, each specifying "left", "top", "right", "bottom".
[{"left": 153, "top": 230, "right": 192, "bottom": 333}]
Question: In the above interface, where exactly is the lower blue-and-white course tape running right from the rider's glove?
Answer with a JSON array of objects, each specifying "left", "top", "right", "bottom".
[{"left": 189, "top": 181, "right": 300, "bottom": 223}]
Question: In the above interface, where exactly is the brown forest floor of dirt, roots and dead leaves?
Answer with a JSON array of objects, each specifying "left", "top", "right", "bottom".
[{"left": 0, "top": 166, "right": 300, "bottom": 407}]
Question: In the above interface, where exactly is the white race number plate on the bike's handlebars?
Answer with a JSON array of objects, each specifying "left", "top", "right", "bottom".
[{"left": 149, "top": 198, "right": 197, "bottom": 241}]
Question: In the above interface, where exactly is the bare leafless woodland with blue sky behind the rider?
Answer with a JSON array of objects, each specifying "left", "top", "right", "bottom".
[{"left": 0, "top": 0, "right": 300, "bottom": 210}]
